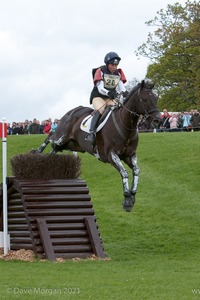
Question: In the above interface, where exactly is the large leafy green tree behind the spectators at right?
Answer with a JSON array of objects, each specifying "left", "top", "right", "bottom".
[{"left": 136, "top": 1, "right": 200, "bottom": 111}]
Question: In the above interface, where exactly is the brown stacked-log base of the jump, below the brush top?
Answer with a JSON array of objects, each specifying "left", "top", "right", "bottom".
[{"left": 0, "top": 154, "right": 106, "bottom": 260}]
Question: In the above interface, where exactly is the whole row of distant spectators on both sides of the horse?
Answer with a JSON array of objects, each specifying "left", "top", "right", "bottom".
[{"left": 7, "top": 109, "right": 200, "bottom": 135}]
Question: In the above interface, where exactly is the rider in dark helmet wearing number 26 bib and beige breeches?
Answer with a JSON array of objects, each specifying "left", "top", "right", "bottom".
[{"left": 86, "top": 52, "right": 128, "bottom": 143}]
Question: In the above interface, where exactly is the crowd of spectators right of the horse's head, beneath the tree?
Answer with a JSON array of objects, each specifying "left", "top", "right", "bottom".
[{"left": 138, "top": 109, "right": 200, "bottom": 132}]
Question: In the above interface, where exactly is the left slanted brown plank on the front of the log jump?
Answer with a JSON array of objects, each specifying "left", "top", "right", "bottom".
[{"left": 36, "top": 218, "right": 56, "bottom": 260}]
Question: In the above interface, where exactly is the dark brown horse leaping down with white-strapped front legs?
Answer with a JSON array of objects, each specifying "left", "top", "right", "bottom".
[{"left": 34, "top": 80, "right": 161, "bottom": 212}]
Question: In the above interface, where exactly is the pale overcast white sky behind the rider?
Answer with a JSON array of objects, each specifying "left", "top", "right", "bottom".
[{"left": 0, "top": 0, "right": 186, "bottom": 122}]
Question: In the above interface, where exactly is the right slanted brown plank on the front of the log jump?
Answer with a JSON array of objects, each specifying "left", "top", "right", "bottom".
[{"left": 85, "top": 217, "right": 106, "bottom": 258}]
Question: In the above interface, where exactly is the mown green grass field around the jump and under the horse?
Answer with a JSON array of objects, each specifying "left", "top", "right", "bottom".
[{"left": 0, "top": 132, "right": 200, "bottom": 300}]
